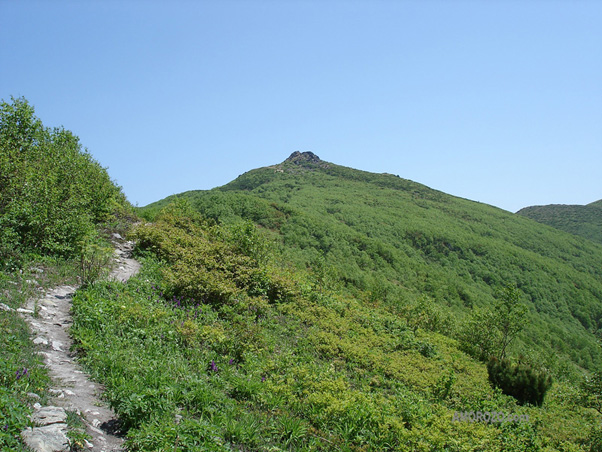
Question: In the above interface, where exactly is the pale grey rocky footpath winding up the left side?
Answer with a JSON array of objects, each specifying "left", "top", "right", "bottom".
[{"left": 21, "top": 238, "right": 140, "bottom": 452}]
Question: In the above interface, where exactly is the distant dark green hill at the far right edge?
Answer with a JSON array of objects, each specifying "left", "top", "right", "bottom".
[{"left": 517, "top": 200, "right": 602, "bottom": 243}]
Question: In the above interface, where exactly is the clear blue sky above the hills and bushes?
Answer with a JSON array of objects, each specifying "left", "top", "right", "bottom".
[{"left": 0, "top": 0, "right": 602, "bottom": 211}]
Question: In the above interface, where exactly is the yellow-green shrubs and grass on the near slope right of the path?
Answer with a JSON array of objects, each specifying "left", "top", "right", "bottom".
[{"left": 72, "top": 202, "right": 599, "bottom": 451}]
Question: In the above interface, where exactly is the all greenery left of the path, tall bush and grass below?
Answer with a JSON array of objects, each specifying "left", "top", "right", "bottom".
[{"left": 0, "top": 98, "right": 135, "bottom": 451}]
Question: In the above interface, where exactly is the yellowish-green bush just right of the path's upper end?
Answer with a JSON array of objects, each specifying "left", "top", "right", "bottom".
[{"left": 132, "top": 202, "right": 295, "bottom": 305}]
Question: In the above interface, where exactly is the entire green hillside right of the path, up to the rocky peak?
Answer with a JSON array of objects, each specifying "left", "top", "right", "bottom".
[{"left": 62, "top": 153, "right": 602, "bottom": 452}]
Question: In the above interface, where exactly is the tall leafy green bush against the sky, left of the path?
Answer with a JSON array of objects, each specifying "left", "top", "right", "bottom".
[{"left": 0, "top": 94, "right": 128, "bottom": 268}]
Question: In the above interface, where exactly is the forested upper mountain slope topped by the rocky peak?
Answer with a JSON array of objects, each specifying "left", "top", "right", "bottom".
[{"left": 145, "top": 153, "right": 602, "bottom": 373}]
